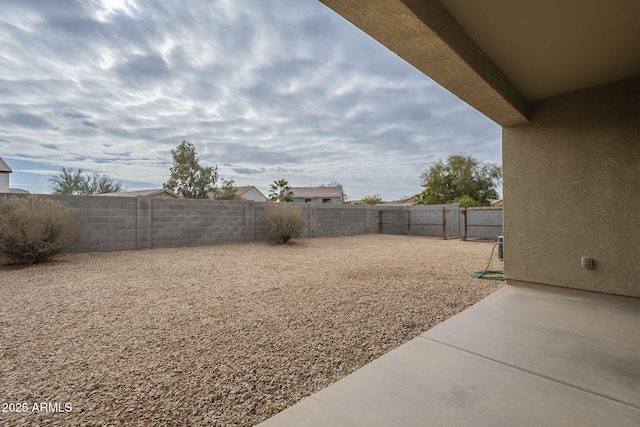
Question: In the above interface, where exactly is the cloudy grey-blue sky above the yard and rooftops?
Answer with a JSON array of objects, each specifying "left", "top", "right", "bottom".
[{"left": 0, "top": 0, "right": 501, "bottom": 200}]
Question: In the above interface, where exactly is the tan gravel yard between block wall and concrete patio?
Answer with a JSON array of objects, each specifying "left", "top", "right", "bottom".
[{"left": 0, "top": 235, "right": 502, "bottom": 426}]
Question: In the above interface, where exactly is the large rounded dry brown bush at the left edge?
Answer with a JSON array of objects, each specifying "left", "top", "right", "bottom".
[{"left": 0, "top": 196, "right": 79, "bottom": 264}]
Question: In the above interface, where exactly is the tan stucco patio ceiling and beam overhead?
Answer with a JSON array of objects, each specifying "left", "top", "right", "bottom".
[{"left": 321, "top": 0, "right": 640, "bottom": 126}]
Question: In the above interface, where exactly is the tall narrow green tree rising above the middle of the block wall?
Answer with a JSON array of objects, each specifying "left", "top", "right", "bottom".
[{"left": 163, "top": 141, "right": 218, "bottom": 199}]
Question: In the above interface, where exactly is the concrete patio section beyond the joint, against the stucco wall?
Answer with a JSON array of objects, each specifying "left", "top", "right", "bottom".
[{"left": 422, "top": 286, "right": 640, "bottom": 409}]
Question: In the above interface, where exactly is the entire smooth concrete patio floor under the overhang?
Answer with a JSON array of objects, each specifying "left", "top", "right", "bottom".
[{"left": 260, "top": 286, "right": 640, "bottom": 427}]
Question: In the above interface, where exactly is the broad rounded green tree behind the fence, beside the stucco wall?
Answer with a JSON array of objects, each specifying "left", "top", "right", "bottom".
[{"left": 415, "top": 154, "right": 502, "bottom": 207}]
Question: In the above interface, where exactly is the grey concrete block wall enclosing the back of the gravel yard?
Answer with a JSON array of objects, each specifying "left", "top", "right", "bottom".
[{"left": 0, "top": 195, "right": 502, "bottom": 252}]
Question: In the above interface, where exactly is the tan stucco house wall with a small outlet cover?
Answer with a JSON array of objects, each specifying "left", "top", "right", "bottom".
[{"left": 503, "top": 79, "right": 640, "bottom": 297}]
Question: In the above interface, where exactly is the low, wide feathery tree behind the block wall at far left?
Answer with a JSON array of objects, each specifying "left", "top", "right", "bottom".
[{"left": 49, "top": 168, "right": 125, "bottom": 195}]
